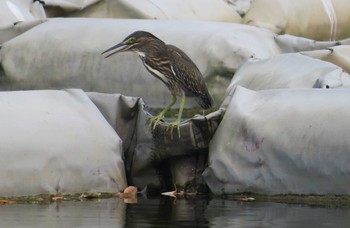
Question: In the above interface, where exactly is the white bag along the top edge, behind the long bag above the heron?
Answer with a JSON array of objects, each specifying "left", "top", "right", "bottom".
[{"left": 64, "top": 0, "right": 242, "bottom": 23}]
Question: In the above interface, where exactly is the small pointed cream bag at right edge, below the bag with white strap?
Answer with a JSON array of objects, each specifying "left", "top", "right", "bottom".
[{"left": 303, "top": 45, "right": 350, "bottom": 73}]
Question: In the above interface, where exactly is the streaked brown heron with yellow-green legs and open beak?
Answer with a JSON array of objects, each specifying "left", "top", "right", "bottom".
[{"left": 102, "top": 31, "right": 213, "bottom": 137}]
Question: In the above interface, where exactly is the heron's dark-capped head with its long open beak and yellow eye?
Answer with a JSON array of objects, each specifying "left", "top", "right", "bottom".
[{"left": 102, "top": 31, "right": 163, "bottom": 58}]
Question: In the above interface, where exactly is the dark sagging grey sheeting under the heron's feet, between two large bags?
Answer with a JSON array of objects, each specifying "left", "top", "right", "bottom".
[{"left": 87, "top": 92, "right": 223, "bottom": 188}]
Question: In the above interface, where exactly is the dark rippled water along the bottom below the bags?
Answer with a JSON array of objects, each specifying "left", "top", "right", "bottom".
[{"left": 0, "top": 197, "right": 350, "bottom": 228}]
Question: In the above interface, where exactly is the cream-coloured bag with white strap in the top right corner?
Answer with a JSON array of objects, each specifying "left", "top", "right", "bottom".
[{"left": 244, "top": 0, "right": 350, "bottom": 40}]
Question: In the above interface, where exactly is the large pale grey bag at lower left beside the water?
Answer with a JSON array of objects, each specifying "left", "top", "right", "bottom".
[{"left": 0, "top": 90, "right": 126, "bottom": 196}]
